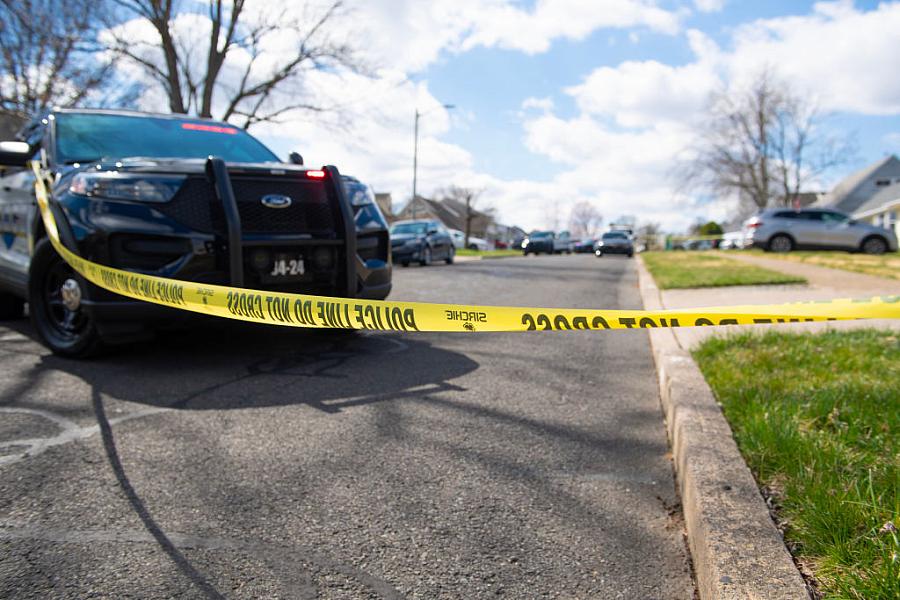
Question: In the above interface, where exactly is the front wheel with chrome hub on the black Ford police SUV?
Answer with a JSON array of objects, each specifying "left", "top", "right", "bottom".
[{"left": 28, "top": 239, "right": 102, "bottom": 358}]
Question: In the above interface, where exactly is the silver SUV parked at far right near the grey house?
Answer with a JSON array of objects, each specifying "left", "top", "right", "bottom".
[{"left": 744, "top": 208, "right": 897, "bottom": 254}]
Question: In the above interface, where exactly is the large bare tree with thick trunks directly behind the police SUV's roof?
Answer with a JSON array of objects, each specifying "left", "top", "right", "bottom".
[{"left": 110, "top": 0, "right": 363, "bottom": 128}]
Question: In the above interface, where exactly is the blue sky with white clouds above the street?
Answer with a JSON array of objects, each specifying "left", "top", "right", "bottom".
[{"left": 244, "top": 0, "right": 900, "bottom": 231}]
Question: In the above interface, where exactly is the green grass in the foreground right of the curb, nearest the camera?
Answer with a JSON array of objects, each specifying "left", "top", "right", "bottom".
[{"left": 694, "top": 330, "right": 900, "bottom": 600}]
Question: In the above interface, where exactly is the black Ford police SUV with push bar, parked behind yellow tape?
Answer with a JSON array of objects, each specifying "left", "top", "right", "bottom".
[{"left": 0, "top": 109, "right": 391, "bottom": 356}]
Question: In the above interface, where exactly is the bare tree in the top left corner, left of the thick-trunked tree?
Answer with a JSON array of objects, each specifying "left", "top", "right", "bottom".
[{"left": 0, "top": 0, "right": 128, "bottom": 123}]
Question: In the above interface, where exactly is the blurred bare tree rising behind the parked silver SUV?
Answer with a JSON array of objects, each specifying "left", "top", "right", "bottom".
[{"left": 681, "top": 70, "right": 853, "bottom": 209}]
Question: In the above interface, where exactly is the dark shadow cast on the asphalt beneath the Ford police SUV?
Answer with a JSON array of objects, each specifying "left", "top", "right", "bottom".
[{"left": 23, "top": 323, "right": 478, "bottom": 413}]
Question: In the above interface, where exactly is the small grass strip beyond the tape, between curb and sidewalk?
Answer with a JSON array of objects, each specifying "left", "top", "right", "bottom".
[{"left": 641, "top": 251, "right": 806, "bottom": 289}]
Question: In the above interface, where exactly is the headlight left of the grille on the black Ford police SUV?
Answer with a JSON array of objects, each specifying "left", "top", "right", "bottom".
[{"left": 69, "top": 173, "right": 184, "bottom": 202}]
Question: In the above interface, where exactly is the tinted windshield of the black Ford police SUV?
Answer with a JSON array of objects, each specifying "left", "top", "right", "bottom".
[{"left": 56, "top": 113, "right": 278, "bottom": 164}]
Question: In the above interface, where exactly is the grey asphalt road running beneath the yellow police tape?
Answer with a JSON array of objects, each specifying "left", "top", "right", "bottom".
[{"left": 0, "top": 256, "right": 693, "bottom": 599}]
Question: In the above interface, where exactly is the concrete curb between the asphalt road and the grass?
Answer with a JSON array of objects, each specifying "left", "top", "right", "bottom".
[{"left": 638, "top": 260, "right": 809, "bottom": 600}]
